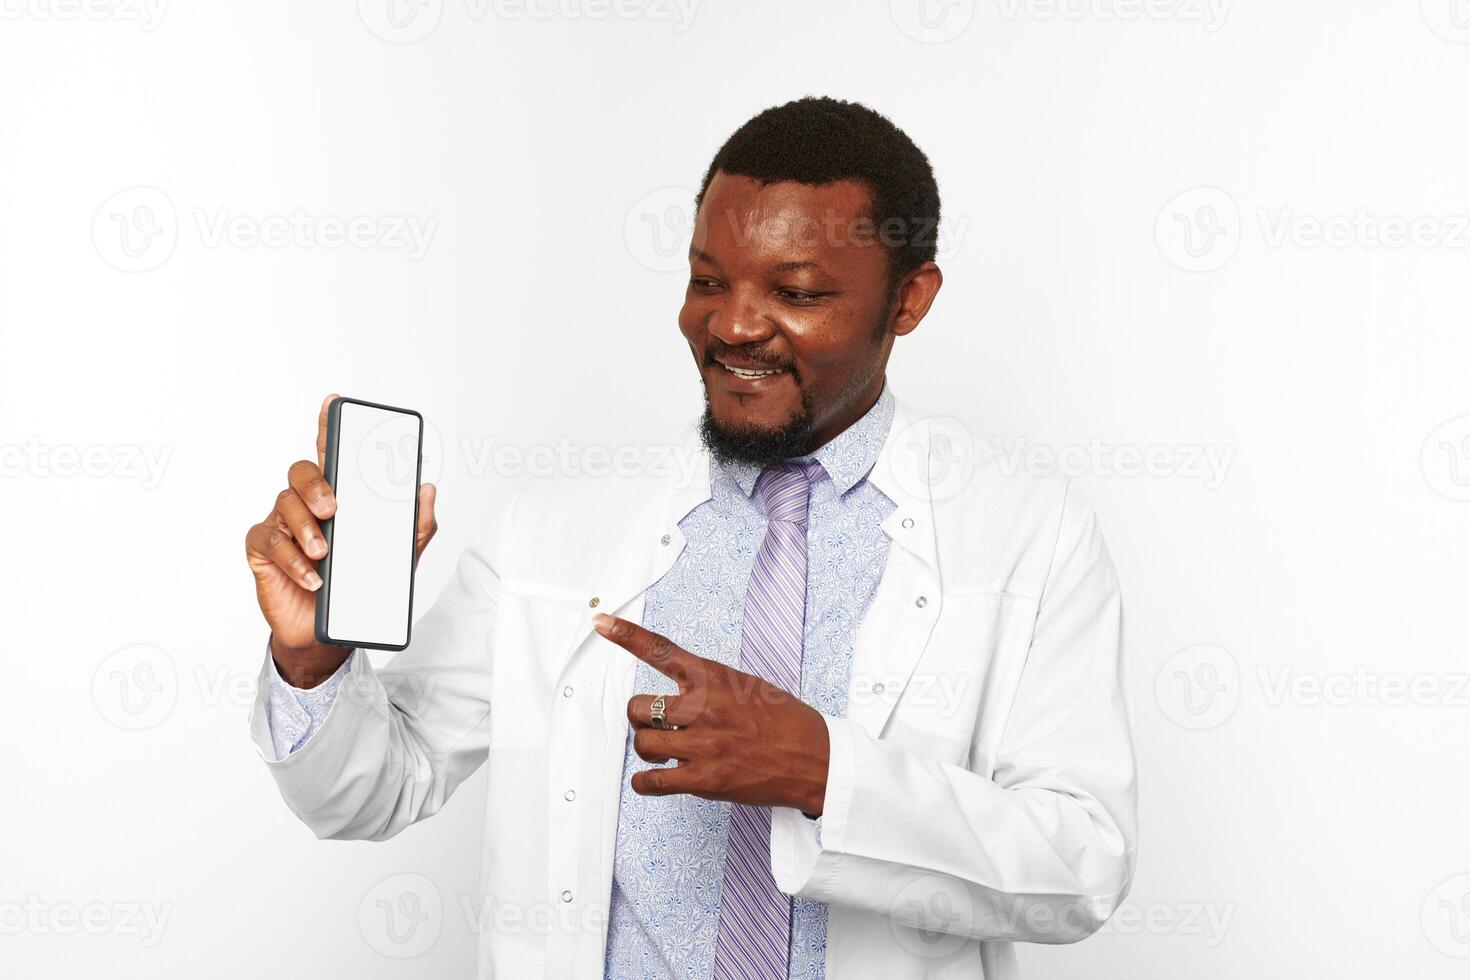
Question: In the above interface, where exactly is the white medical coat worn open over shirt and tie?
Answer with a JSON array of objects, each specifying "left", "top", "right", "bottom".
[{"left": 251, "top": 401, "right": 1136, "bottom": 980}]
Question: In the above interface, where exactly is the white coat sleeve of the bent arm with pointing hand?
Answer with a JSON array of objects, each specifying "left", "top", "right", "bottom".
[{"left": 772, "top": 486, "right": 1138, "bottom": 943}]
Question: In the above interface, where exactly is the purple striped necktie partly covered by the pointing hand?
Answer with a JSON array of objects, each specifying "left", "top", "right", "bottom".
[{"left": 714, "top": 460, "right": 825, "bottom": 980}]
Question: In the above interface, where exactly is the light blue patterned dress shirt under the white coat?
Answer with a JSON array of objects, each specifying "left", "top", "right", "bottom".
[{"left": 266, "top": 383, "right": 894, "bottom": 980}]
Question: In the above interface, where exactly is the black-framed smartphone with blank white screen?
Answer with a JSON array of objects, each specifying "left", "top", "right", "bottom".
[{"left": 316, "top": 398, "right": 423, "bottom": 649}]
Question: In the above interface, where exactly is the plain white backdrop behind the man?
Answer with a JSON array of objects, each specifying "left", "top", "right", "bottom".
[{"left": 0, "top": 0, "right": 1470, "bottom": 980}]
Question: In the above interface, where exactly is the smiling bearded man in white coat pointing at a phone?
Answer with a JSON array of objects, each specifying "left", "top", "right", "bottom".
[{"left": 247, "top": 98, "right": 1136, "bottom": 980}]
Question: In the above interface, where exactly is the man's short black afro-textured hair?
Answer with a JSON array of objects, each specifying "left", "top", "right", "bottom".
[{"left": 694, "top": 96, "right": 939, "bottom": 287}]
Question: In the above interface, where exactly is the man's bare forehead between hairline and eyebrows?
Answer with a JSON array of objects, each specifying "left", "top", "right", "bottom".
[{"left": 691, "top": 170, "right": 886, "bottom": 270}]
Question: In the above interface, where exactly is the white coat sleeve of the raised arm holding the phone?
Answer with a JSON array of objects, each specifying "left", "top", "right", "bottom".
[{"left": 250, "top": 501, "right": 515, "bottom": 840}]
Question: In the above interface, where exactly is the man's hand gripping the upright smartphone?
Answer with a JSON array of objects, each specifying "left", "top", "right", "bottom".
[{"left": 245, "top": 395, "right": 438, "bottom": 688}]
